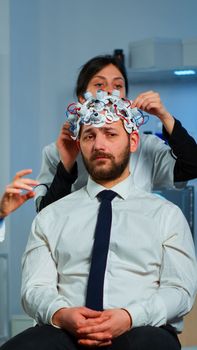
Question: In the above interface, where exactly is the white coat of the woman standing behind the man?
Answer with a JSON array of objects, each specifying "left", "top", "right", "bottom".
[{"left": 35, "top": 134, "right": 175, "bottom": 204}]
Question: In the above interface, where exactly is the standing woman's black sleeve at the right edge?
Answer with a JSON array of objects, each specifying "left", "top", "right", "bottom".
[{"left": 163, "top": 119, "right": 197, "bottom": 182}]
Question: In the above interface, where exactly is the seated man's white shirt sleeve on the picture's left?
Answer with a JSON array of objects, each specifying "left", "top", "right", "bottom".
[{"left": 21, "top": 219, "right": 68, "bottom": 324}]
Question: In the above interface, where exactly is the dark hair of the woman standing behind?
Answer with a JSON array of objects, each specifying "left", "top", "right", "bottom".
[{"left": 75, "top": 55, "right": 128, "bottom": 97}]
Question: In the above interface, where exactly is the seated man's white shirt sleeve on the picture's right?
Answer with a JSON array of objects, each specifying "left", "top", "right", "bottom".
[{"left": 127, "top": 206, "right": 197, "bottom": 330}]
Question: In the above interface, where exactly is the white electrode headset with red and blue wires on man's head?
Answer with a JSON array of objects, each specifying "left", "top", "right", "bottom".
[{"left": 66, "top": 90, "right": 147, "bottom": 140}]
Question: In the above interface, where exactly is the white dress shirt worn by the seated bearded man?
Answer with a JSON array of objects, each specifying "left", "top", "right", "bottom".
[{"left": 22, "top": 176, "right": 197, "bottom": 331}]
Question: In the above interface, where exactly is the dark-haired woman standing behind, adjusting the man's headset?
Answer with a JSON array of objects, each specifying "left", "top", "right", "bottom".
[{"left": 35, "top": 55, "right": 197, "bottom": 211}]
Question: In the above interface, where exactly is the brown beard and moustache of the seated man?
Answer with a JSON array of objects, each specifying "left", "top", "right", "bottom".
[{"left": 82, "top": 147, "right": 130, "bottom": 182}]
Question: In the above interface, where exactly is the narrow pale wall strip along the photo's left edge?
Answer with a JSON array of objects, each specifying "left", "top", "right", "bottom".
[{"left": 0, "top": 0, "right": 10, "bottom": 344}]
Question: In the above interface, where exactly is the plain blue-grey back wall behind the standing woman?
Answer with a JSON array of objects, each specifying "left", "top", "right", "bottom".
[{"left": 5, "top": 0, "right": 197, "bottom": 320}]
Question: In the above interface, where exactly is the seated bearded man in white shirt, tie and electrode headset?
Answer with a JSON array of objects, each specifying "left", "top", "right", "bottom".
[{"left": 1, "top": 95, "right": 197, "bottom": 350}]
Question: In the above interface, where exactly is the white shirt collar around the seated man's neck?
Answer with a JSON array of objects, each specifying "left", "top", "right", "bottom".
[{"left": 86, "top": 174, "right": 134, "bottom": 199}]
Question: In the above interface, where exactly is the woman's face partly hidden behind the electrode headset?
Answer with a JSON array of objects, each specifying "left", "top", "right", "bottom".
[{"left": 87, "top": 64, "right": 126, "bottom": 98}]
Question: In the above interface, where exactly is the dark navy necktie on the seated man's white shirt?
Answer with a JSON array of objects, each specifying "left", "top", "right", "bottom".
[{"left": 86, "top": 190, "right": 117, "bottom": 311}]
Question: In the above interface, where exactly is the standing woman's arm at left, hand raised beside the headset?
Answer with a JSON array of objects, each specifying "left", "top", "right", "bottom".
[{"left": 36, "top": 123, "right": 79, "bottom": 211}]
